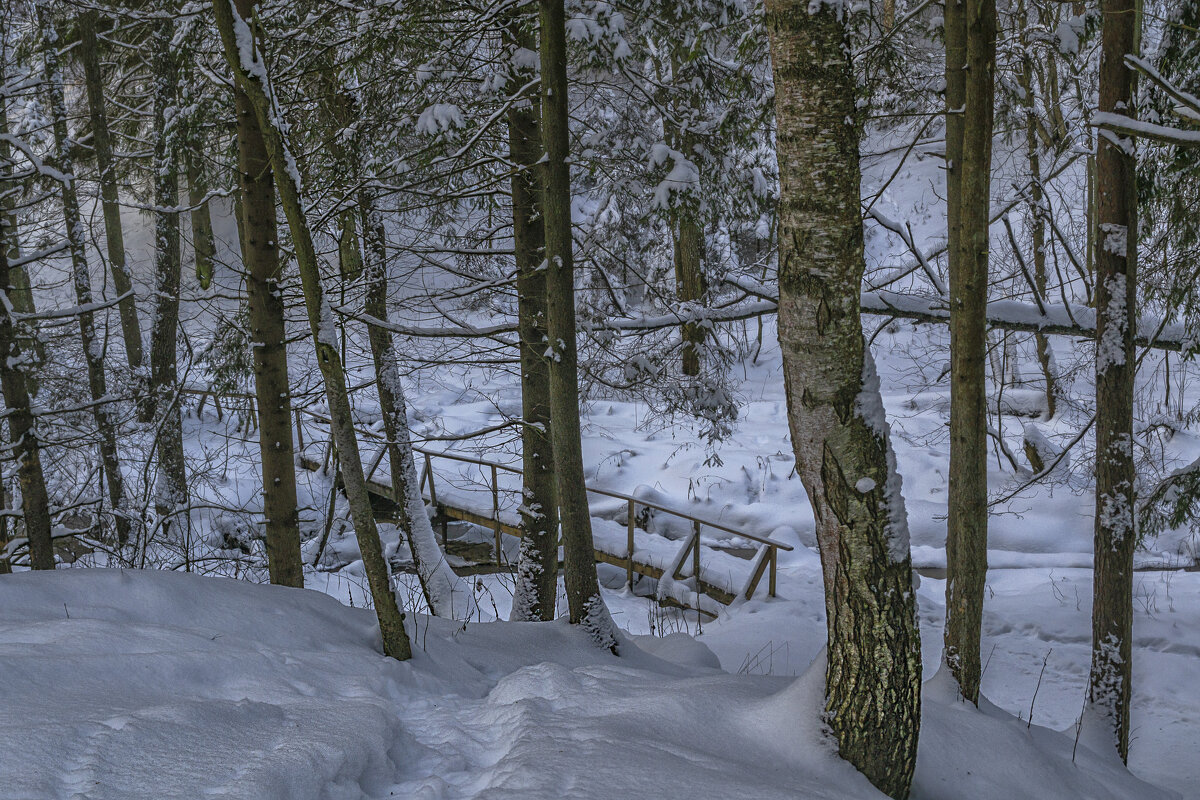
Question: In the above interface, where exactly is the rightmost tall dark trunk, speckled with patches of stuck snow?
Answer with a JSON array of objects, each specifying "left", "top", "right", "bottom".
[{"left": 1087, "top": 0, "right": 1138, "bottom": 760}]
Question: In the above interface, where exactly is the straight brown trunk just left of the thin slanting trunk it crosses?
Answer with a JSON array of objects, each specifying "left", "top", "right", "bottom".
[{"left": 234, "top": 28, "right": 304, "bottom": 587}]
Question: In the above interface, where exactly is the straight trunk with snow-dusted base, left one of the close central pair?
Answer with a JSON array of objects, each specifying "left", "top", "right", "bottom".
[{"left": 504, "top": 16, "right": 558, "bottom": 621}]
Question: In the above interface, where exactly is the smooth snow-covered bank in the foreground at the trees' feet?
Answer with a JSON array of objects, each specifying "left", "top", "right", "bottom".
[{"left": 0, "top": 567, "right": 1180, "bottom": 800}]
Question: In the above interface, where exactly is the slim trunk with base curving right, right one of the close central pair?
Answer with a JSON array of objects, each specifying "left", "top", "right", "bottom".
[{"left": 538, "top": 0, "right": 617, "bottom": 652}]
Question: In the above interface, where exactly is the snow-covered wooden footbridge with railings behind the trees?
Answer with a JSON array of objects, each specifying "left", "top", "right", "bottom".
[{"left": 196, "top": 397, "right": 792, "bottom": 616}]
